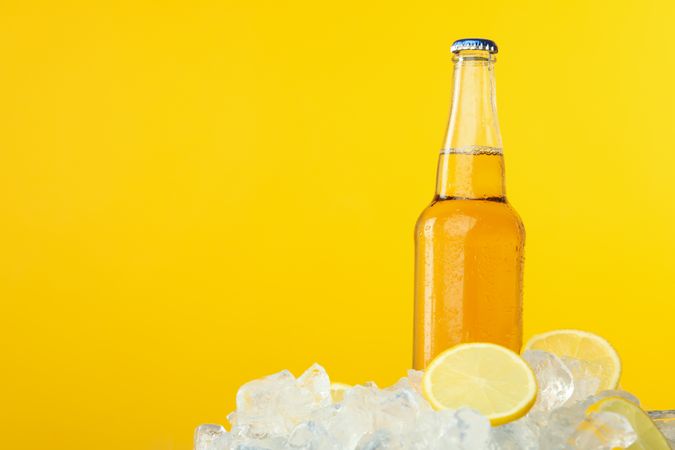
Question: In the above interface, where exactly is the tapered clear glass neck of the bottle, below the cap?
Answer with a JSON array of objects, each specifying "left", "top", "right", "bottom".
[{"left": 436, "top": 50, "right": 506, "bottom": 201}]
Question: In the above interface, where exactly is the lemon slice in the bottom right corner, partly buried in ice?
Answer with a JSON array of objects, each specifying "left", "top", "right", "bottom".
[{"left": 586, "top": 397, "right": 670, "bottom": 450}]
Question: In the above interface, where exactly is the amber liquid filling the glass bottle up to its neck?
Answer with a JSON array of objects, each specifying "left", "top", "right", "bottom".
[{"left": 413, "top": 152, "right": 525, "bottom": 369}]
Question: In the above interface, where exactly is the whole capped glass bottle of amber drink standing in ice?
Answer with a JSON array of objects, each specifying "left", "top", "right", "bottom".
[{"left": 413, "top": 39, "right": 525, "bottom": 369}]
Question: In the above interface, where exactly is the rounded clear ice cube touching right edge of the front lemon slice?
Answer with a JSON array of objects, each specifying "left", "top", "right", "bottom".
[{"left": 523, "top": 350, "right": 574, "bottom": 411}]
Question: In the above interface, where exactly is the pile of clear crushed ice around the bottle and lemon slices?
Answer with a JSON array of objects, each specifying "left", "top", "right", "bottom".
[{"left": 195, "top": 351, "right": 672, "bottom": 450}]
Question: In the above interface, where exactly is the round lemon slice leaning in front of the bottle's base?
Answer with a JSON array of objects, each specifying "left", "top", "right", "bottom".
[{"left": 422, "top": 343, "right": 537, "bottom": 425}]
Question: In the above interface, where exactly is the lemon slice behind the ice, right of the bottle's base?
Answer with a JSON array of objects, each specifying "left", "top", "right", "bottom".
[{"left": 523, "top": 330, "right": 621, "bottom": 391}]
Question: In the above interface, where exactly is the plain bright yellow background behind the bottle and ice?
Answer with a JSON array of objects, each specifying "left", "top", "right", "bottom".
[{"left": 0, "top": 0, "right": 675, "bottom": 450}]
